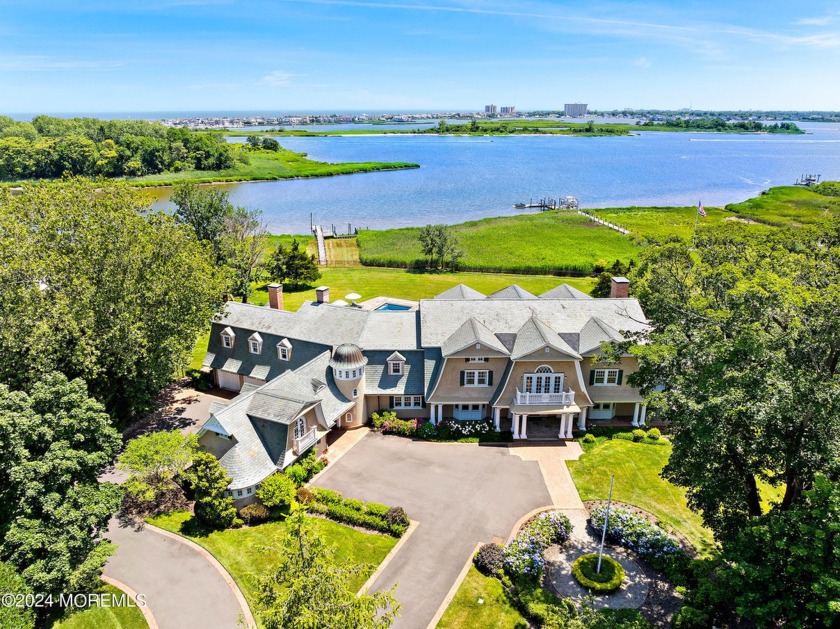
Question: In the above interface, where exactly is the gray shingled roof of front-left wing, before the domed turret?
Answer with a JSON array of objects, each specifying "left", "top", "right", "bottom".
[{"left": 208, "top": 351, "right": 354, "bottom": 490}]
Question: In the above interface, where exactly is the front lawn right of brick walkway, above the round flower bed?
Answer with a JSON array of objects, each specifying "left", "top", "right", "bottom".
[{"left": 566, "top": 439, "right": 714, "bottom": 554}]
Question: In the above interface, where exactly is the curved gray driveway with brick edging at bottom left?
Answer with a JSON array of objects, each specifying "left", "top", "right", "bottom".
[{"left": 105, "top": 518, "right": 247, "bottom": 629}]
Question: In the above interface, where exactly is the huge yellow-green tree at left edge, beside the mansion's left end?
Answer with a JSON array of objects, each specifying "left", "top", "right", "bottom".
[{"left": 0, "top": 180, "right": 225, "bottom": 420}]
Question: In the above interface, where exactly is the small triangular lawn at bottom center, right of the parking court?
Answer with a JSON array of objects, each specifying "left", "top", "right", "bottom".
[{"left": 437, "top": 566, "right": 528, "bottom": 629}]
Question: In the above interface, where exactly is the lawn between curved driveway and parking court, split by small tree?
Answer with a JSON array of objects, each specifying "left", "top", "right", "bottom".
[{"left": 148, "top": 511, "right": 397, "bottom": 616}]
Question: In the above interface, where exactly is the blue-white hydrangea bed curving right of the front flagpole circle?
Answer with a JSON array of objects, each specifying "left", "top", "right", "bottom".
[{"left": 589, "top": 506, "right": 688, "bottom": 575}]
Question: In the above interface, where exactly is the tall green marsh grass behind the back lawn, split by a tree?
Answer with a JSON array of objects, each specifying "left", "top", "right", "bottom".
[{"left": 358, "top": 211, "right": 639, "bottom": 274}]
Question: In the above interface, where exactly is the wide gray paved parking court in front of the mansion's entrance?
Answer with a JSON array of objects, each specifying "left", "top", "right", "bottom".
[{"left": 317, "top": 433, "right": 551, "bottom": 628}]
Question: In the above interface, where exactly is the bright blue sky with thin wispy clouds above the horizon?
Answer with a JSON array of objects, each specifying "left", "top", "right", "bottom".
[{"left": 0, "top": 0, "right": 840, "bottom": 112}]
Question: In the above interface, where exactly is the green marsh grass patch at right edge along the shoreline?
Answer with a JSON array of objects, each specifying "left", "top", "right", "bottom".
[{"left": 726, "top": 186, "right": 840, "bottom": 227}]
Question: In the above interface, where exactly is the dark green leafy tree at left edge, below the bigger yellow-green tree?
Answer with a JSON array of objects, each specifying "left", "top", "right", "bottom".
[{"left": 0, "top": 374, "right": 121, "bottom": 594}]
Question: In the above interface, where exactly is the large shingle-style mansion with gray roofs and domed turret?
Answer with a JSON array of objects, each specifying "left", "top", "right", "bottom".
[{"left": 199, "top": 278, "right": 647, "bottom": 501}]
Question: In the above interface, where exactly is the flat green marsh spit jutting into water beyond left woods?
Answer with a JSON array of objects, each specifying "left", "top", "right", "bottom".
[{"left": 128, "top": 148, "right": 419, "bottom": 186}]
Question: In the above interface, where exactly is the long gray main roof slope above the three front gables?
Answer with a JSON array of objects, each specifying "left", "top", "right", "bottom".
[{"left": 420, "top": 298, "right": 648, "bottom": 347}]
